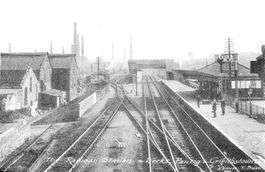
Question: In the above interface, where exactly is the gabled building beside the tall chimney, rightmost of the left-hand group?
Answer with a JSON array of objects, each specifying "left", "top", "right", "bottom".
[{"left": 48, "top": 54, "right": 79, "bottom": 101}]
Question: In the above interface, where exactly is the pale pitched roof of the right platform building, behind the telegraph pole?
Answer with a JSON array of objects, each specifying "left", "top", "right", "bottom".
[{"left": 197, "top": 62, "right": 258, "bottom": 77}]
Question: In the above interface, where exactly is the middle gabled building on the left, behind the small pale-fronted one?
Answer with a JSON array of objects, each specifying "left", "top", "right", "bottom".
[{"left": 1, "top": 53, "right": 52, "bottom": 91}]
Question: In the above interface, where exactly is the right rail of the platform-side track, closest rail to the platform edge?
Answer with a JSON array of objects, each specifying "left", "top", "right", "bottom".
[{"left": 154, "top": 78, "right": 239, "bottom": 172}]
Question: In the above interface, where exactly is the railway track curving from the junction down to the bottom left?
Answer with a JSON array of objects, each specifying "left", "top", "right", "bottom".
[{"left": 44, "top": 100, "right": 122, "bottom": 172}]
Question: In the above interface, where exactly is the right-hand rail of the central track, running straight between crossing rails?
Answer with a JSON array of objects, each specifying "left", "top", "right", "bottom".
[{"left": 146, "top": 78, "right": 179, "bottom": 172}]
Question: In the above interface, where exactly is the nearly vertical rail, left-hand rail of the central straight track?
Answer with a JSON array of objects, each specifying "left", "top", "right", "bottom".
[{"left": 142, "top": 77, "right": 152, "bottom": 172}]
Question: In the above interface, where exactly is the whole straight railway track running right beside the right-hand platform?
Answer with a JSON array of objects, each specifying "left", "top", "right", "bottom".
[{"left": 150, "top": 78, "right": 263, "bottom": 171}]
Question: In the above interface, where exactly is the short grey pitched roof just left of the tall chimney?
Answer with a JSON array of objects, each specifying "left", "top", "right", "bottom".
[{"left": 48, "top": 54, "right": 76, "bottom": 69}]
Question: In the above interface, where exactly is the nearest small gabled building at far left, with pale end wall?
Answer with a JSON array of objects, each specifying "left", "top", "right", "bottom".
[{"left": 0, "top": 66, "right": 40, "bottom": 111}]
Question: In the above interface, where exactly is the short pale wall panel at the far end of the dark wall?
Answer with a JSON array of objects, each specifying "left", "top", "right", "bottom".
[{"left": 78, "top": 92, "right": 97, "bottom": 117}]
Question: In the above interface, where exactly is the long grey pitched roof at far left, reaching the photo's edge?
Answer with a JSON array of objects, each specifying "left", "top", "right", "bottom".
[{"left": 1, "top": 53, "right": 48, "bottom": 70}]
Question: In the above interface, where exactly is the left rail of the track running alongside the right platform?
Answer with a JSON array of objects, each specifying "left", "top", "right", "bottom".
[{"left": 148, "top": 76, "right": 212, "bottom": 172}]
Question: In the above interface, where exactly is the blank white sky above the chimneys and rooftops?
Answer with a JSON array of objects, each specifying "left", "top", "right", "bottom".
[{"left": 0, "top": 0, "right": 265, "bottom": 61}]
